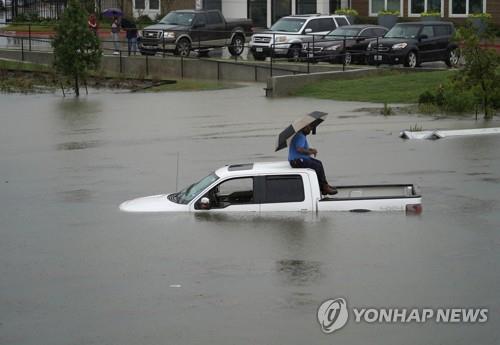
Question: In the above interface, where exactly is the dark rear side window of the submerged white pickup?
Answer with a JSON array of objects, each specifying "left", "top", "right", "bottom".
[{"left": 264, "top": 175, "right": 305, "bottom": 203}]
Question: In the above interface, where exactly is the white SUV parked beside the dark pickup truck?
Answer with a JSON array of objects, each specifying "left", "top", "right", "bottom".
[{"left": 249, "top": 14, "right": 350, "bottom": 60}]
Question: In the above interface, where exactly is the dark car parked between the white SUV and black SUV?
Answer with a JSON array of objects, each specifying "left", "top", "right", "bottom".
[{"left": 302, "top": 25, "right": 388, "bottom": 65}]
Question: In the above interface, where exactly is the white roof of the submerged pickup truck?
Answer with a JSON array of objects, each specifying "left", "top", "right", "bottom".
[{"left": 215, "top": 161, "right": 304, "bottom": 177}]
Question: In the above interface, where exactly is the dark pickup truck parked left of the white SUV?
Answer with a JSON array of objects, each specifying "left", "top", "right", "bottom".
[{"left": 138, "top": 10, "right": 252, "bottom": 56}]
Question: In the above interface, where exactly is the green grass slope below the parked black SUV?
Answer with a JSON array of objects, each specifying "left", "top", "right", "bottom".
[{"left": 293, "top": 71, "right": 455, "bottom": 103}]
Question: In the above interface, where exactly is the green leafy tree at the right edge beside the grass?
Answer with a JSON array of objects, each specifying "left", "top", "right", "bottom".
[{"left": 455, "top": 23, "right": 500, "bottom": 118}]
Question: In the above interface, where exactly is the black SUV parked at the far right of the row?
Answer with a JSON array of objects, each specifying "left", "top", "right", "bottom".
[{"left": 367, "top": 22, "right": 459, "bottom": 68}]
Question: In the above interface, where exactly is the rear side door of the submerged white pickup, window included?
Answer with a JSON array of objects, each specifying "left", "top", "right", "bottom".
[{"left": 257, "top": 174, "right": 313, "bottom": 212}]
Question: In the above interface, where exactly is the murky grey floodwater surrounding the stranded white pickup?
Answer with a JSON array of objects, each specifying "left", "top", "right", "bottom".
[{"left": 0, "top": 84, "right": 500, "bottom": 345}]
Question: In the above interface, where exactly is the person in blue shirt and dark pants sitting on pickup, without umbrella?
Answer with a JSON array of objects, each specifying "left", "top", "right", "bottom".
[{"left": 288, "top": 125, "right": 337, "bottom": 195}]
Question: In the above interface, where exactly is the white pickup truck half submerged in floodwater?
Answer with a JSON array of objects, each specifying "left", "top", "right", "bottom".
[{"left": 120, "top": 162, "right": 422, "bottom": 213}]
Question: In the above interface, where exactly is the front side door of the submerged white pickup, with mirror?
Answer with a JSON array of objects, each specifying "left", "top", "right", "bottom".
[{"left": 194, "top": 177, "right": 260, "bottom": 212}]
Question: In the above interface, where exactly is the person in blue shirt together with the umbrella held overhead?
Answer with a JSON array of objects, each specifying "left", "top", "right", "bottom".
[{"left": 276, "top": 111, "right": 337, "bottom": 195}]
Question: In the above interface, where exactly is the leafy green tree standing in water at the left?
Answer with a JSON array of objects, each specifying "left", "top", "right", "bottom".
[{"left": 52, "top": 0, "right": 102, "bottom": 97}]
